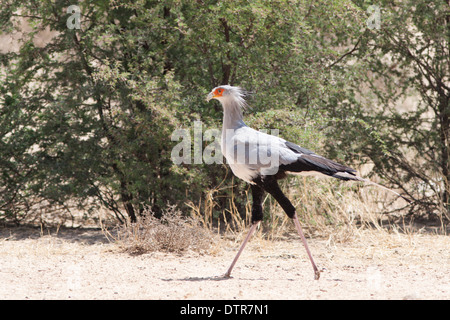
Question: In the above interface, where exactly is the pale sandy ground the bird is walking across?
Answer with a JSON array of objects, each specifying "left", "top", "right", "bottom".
[{"left": 0, "top": 228, "right": 450, "bottom": 300}]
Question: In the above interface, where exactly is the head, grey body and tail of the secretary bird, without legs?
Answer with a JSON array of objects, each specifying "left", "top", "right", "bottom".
[{"left": 207, "top": 85, "right": 403, "bottom": 198}]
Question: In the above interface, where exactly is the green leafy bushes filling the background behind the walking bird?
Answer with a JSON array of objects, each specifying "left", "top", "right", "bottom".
[{"left": 0, "top": 0, "right": 450, "bottom": 222}]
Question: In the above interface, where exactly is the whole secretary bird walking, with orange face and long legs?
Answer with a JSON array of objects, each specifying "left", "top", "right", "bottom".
[{"left": 206, "top": 85, "right": 403, "bottom": 280}]
